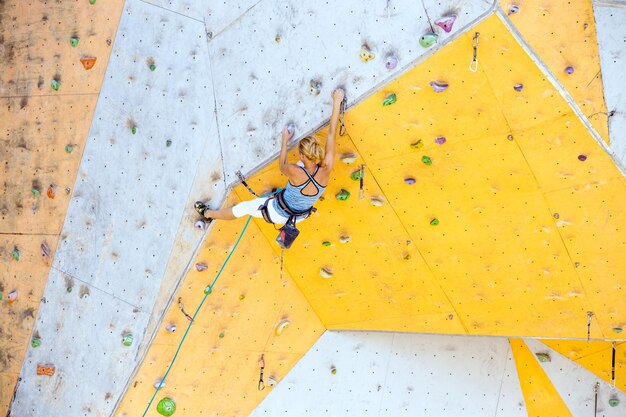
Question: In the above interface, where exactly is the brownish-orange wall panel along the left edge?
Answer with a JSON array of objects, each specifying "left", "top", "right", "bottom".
[{"left": 0, "top": 0, "right": 123, "bottom": 415}]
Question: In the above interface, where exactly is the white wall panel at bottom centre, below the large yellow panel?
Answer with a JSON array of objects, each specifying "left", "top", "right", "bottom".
[{"left": 250, "top": 331, "right": 528, "bottom": 417}]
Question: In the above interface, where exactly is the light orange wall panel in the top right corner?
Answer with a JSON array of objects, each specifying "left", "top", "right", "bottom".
[{"left": 500, "top": 0, "right": 609, "bottom": 143}]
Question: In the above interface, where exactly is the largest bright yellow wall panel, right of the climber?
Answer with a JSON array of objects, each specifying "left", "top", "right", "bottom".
[{"left": 237, "top": 16, "right": 626, "bottom": 338}]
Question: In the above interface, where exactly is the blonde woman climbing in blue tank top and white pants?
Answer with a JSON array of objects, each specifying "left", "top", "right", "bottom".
[{"left": 195, "top": 88, "right": 345, "bottom": 224}]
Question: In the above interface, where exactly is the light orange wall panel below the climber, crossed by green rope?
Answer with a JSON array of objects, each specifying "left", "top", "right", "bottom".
[{"left": 116, "top": 193, "right": 324, "bottom": 417}]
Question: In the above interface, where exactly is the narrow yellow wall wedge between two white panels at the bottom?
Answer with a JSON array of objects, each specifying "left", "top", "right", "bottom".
[{"left": 510, "top": 339, "right": 572, "bottom": 417}]
